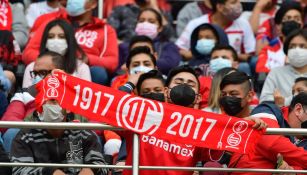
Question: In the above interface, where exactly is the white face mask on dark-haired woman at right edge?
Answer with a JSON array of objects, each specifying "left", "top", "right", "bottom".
[{"left": 288, "top": 47, "right": 307, "bottom": 68}]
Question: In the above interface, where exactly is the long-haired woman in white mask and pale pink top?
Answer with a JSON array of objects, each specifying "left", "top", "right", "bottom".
[{"left": 22, "top": 19, "right": 91, "bottom": 88}]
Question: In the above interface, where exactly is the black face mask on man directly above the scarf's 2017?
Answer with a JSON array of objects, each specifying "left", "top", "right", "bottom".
[{"left": 170, "top": 84, "right": 196, "bottom": 107}]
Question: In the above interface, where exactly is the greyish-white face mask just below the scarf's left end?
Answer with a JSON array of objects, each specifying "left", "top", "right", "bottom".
[{"left": 39, "top": 104, "right": 64, "bottom": 122}]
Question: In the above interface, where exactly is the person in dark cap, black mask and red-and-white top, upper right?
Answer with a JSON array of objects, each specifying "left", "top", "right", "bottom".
[{"left": 252, "top": 2, "right": 303, "bottom": 73}]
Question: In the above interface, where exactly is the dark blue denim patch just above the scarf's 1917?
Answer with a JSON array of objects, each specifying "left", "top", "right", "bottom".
[{"left": 90, "top": 66, "right": 109, "bottom": 85}]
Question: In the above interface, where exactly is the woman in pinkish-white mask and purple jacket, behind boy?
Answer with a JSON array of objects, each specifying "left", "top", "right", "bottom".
[{"left": 119, "top": 8, "right": 181, "bottom": 74}]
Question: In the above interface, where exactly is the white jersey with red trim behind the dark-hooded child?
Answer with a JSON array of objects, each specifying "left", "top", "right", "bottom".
[{"left": 176, "top": 14, "right": 256, "bottom": 54}]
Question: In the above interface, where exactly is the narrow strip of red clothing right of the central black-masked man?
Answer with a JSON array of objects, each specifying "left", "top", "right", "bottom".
[{"left": 198, "top": 76, "right": 212, "bottom": 109}]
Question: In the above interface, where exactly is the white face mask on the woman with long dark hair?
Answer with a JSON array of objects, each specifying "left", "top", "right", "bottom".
[{"left": 46, "top": 38, "right": 68, "bottom": 56}]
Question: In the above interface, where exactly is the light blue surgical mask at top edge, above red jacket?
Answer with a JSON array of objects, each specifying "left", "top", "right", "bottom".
[{"left": 66, "top": 0, "right": 86, "bottom": 16}]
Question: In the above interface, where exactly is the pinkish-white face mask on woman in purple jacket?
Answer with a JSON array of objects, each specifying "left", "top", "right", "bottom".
[{"left": 135, "top": 21, "right": 158, "bottom": 39}]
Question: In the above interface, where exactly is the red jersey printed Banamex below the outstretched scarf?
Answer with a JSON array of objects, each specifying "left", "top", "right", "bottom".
[{"left": 123, "top": 131, "right": 223, "bottom": 175}]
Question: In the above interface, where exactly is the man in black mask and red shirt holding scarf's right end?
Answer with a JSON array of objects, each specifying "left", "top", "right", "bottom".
[{"left": 220, "top": 72, "right": 307, "bottom": 175}]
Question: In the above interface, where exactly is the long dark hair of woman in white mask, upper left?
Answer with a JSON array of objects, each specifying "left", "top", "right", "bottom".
[{"left": 39, "top": 19, "right": 85, "bottom": 74}]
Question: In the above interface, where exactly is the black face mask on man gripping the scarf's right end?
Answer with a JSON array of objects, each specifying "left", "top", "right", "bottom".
[{"left": 219, "top": 96, "right": 243, "bottom": 116}]
